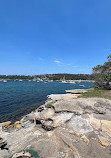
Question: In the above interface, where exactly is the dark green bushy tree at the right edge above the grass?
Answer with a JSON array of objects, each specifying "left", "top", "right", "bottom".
[{"left": 93, "top": 55, "right": 111, "bottom": 89}]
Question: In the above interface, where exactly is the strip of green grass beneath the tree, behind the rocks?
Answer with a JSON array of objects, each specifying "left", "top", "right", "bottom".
[{"left": 79, "top": 89, "right": 111, "bottom": 99}]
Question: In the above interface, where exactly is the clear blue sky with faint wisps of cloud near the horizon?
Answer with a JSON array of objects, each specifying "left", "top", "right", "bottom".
[{"left": 0, "top": 0, "right": 111, "bottom": 75}]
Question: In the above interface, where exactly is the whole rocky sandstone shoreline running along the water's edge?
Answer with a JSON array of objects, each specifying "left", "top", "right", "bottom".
[{"left": 0, "top": 90, "right": 111, "bottom": 158}]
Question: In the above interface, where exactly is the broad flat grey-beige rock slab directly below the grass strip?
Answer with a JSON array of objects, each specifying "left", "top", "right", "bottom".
[{"left": 53, "top": 98, "right": 111, "bottom": 115}]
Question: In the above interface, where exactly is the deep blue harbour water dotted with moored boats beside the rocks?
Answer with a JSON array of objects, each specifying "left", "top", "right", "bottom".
[{"left": 0, "top": 80, "right": 93, "bottom": 122}]
